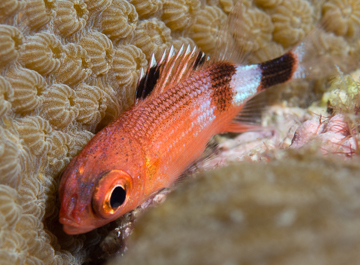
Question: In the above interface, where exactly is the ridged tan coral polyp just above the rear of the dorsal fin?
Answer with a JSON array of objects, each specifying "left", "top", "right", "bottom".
[{"left": 190, "top": 6, "right": 226, "bottom": 53}]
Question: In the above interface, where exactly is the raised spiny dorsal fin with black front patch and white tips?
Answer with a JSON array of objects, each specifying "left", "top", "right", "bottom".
[{"left": 135, "top": 45, "right": 205, "bottom": 102}]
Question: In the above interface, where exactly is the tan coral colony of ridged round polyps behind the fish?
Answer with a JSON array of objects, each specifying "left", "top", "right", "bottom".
[{"left": 0, "top": 0, "right": 360, "bottom": 265}]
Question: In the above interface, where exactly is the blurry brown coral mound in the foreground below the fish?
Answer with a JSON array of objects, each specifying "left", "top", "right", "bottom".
[{"left": 112, "top": 155, "right": 360, "bottom": 265}]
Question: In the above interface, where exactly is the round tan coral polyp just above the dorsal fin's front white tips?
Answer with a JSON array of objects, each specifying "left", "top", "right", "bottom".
[{"left": 132, "top": 18, "right": 171, "bottom": 60}]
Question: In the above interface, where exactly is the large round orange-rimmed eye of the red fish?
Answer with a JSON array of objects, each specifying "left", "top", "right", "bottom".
[{"left": 91, "top": 170, "right": 132, "bottom": 218}]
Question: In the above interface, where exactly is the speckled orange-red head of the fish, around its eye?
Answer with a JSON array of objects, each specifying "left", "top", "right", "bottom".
[{"left": 59, "top": 126, "right": 146, "bottom": 234}]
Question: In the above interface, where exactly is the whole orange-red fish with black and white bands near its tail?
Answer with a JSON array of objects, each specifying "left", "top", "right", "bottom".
[{"left": 59, "top": 16, "right": 320, "bottom": 234}]
